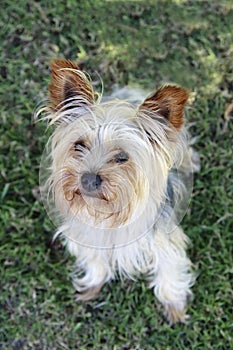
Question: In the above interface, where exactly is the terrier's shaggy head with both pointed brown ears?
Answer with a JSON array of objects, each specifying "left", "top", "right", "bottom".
[{"left": 40, "top": 59, "right": 188, "bottom": 227}]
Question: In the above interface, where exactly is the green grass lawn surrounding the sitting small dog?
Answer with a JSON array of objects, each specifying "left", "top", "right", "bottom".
[{"left": 0, "top": 0, "right": 233, "bottom": 350}]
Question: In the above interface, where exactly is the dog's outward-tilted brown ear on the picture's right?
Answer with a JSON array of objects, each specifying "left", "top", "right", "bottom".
[{"left": 139, "top": 85, "right": 189, "bottom": 130}]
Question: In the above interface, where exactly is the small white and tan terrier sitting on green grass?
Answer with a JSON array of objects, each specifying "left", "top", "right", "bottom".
[{"left": 38, "top": 59, "right": 198, "bottom": 323}]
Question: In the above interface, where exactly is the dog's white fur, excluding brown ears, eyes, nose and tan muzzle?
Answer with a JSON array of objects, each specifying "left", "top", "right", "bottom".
[{"left": 40, "top": 97, "right": 197, "bottom": 322}]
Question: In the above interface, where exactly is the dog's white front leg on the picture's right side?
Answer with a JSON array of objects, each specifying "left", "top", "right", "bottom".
[{"left": 150, "top": 227, "right": 195, "bottom": 324}]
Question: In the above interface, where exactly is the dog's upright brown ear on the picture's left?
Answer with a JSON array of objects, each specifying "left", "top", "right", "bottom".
[{"left": 49, "top": 59, "right": 95, "bottom": 110}]
